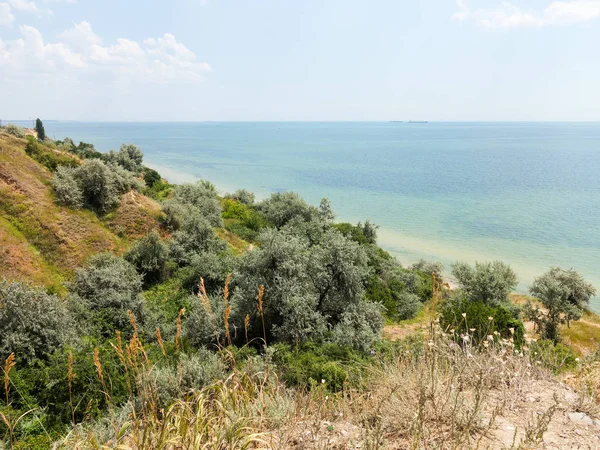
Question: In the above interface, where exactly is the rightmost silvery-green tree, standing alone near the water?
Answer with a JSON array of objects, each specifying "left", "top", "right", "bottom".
[{"left": 525, "top": 267, "right": 596, "bottom": 342}]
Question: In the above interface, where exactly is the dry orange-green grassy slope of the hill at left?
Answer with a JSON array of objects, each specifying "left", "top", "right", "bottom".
[{"left": 0, "top": 133, "right": 160, "bottom": 286}]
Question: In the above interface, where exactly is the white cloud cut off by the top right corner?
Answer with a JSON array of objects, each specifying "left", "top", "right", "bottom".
[{"left": 452, "top": 0, "right": 600, "bottom": 28}]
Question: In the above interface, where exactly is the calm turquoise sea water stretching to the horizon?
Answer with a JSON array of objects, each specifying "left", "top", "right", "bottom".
[{"left": 14, "top": 122, "right": 600, "bottom": 311}]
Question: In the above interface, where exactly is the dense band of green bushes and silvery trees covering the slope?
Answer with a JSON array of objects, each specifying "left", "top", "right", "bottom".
[{"left": 0, "top": 122, "right": 594, "bottom": 448}]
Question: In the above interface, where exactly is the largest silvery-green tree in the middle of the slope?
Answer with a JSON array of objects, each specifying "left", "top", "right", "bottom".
[{"left": 223, "top": 226, "right": 382, "bottom": 349}]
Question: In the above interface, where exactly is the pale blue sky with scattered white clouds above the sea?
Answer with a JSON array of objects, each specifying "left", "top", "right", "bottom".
[{"left": 0, "top": 0, "right": 600, "bottom": 121}]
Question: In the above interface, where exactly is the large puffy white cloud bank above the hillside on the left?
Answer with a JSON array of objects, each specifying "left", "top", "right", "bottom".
[{"left": 0, "top": 22, "right": 210, "bottom": 82}]
